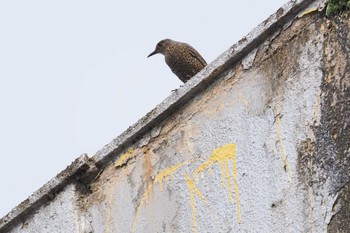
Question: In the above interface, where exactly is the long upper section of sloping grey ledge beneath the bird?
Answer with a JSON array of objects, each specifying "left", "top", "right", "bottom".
[{"left": 93, "top": 0, "right": 327, "bottom": 168}]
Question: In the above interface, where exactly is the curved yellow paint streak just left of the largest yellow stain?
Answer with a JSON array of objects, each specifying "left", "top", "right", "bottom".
[{"left": 131, "top": 162, "right": 187, "bottom": 232}]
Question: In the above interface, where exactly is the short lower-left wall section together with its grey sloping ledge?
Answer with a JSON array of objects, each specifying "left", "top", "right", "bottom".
[{"left": 0, "top": 154, "right": 97, "bottom": 233}]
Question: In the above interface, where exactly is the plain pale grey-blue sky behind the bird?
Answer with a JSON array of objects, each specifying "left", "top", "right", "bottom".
[{"left": 0, "top": 0, "right": 287, "bottom": 218}]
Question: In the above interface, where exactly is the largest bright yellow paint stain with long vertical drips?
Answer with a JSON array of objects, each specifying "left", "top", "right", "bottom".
[{"left": 194, "top": 144, "right": 241, "bottom": 223}]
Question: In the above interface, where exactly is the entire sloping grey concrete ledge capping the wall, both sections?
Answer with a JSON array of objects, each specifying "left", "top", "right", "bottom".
[{"left": 0, "top": 0, "right": 328, "bottom": 232}]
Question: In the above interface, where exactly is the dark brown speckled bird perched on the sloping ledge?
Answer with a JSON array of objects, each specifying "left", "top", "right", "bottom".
[{"left": 148, "top": 39, "right": 207, "bottom": 83}]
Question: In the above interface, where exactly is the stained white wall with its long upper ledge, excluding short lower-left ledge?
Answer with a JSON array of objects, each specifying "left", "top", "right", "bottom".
[{"left": 0, "top": 1, "right": 350, "bottom": 233}]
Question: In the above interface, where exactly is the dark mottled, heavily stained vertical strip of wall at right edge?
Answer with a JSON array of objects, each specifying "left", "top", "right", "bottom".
[{"left": 322, "top": 13, "right": 350, "bottom": 232}]
